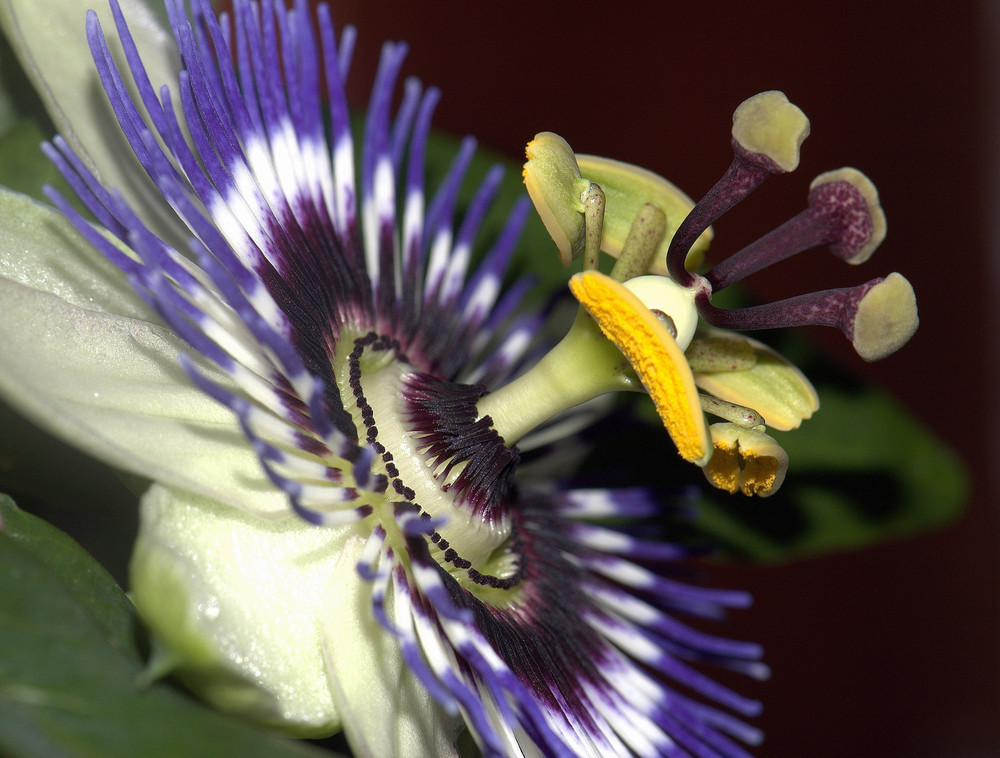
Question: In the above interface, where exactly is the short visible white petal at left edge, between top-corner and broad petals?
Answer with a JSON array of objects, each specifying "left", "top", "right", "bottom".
[{"left": 0, "top": 187, "right": 152, "bottom": 321}]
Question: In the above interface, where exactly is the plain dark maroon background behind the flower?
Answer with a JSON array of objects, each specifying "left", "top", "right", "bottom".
[{"left": 334, "top": 0, "right": 1000, "bottom": 758}]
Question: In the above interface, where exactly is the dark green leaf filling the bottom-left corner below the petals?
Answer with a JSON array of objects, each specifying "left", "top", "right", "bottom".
[{"left": 0, "top": 496, "right": 342, "bottom": 758}]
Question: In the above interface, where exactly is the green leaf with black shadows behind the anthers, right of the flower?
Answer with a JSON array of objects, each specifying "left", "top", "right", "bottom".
[{"left": 581, "top": 374, "right": 968, "bottom": 563}]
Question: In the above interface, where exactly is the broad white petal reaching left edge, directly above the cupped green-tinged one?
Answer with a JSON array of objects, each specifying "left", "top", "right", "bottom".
[{"left": 0, "top": 279, "right": 288, "bottom": 513}]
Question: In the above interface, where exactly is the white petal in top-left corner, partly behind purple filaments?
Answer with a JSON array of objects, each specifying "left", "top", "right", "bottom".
[{"left": 0, "top": 0, "right": 180, "bottom": 242}]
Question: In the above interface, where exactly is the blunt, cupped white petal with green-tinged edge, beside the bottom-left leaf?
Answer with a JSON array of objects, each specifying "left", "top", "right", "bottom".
[{"left": 131, "top": 485, "right": 358, "bottom": 735}]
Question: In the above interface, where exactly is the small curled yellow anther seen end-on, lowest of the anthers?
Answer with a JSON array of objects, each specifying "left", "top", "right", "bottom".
[{"left": 703, "top": 423, "right": 788, "bottom": 497}]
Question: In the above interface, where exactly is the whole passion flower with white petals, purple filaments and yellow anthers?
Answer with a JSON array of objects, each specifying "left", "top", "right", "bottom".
[{"left": 0, "top": 0, "right": 916, "bottom": 756}]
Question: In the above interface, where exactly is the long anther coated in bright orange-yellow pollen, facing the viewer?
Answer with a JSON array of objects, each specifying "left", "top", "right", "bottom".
[{"left": 569, "top": 271, "right": 712, "bottom": 466}]
